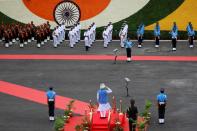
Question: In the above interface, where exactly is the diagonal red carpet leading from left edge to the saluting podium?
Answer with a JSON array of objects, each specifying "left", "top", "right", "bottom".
[{"left": 0, "top": 81, "right": 88, "bottom": 115}]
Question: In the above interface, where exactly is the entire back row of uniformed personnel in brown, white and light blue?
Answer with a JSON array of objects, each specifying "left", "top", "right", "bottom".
[{"left": 0, "top": 21, "right": 195, "bottom": 51}]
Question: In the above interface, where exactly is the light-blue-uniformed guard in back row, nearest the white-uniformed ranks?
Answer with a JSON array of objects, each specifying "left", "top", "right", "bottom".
[{"left": 137, "top": 23, "right": 144, "bottom": 48}]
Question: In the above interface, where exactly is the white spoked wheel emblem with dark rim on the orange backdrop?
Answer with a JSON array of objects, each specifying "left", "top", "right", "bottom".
[{"left": 53, "top": 0, "right": 81, "bottom": 27}]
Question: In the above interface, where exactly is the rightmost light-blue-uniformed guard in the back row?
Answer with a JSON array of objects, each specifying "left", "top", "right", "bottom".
[{"left": 186, "top": 22, "right": 195, "bottom": 48}]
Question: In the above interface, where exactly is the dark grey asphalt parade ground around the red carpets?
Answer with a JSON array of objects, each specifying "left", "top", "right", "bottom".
[{"left": 0, "top": 42, "right": 197, "bottom": 131}]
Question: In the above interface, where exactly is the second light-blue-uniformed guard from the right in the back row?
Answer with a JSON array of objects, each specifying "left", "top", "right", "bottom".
[{"left": 170, "top": 22, "right": 178, "bottom": 51}]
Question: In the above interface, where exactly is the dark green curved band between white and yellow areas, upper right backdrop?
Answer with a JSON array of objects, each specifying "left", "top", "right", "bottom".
[{"left": 114, "top": 0, "right": 184, "bottom": 30}]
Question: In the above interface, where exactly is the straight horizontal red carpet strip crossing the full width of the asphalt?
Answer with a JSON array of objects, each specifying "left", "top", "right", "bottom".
[{"left": 0, "top": 54, "right": 197, "bottom": 61}]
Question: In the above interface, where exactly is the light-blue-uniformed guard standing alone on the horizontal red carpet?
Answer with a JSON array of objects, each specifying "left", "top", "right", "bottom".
[{"left": 124, "top": 38, "right": 134, "bottom": 62}]
